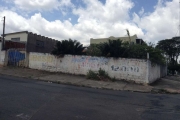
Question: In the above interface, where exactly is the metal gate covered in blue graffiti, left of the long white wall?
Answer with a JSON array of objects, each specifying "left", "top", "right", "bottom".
[{"left": 8, "top": 49, "right": 25, "bottom": 66}]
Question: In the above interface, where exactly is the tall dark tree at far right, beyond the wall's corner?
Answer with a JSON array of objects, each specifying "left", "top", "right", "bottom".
[{"left": 156, "top": 37, "right": 180, "bottom": 75}]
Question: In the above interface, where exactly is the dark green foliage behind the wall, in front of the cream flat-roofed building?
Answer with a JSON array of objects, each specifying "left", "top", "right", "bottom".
[{"left": 88, "top": 39, "right": 165, "bottom": 64}]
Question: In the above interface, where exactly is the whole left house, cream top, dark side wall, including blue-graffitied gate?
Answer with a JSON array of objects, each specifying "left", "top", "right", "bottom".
[{"left": 1, "top": 31, "right": 57, "bottom": 67}]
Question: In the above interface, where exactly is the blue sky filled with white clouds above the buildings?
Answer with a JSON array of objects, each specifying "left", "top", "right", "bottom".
[{"left": 0, "top": 0, "right": 179, "bottom": 45}]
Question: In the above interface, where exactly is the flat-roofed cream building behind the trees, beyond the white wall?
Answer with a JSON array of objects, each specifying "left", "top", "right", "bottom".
[{"left": 90, "top": 35, "right": 144, "bottom": 44}]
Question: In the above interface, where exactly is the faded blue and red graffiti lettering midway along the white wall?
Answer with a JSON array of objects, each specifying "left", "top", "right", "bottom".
[{"left": 71, "top": 56, "right": 109, "bottom": 69}]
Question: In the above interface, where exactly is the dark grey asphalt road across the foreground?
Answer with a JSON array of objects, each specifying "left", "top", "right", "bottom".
[{"left": 0, "top": 75, "right": 180, "bottom": 120}]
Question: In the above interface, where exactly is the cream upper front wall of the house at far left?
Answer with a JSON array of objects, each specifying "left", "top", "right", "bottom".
[{"left": 5, "top": 32, "right": 28, "bottom": 41}]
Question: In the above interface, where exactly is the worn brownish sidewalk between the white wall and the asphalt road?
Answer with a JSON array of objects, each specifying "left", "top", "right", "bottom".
[{"left": 0, "top": 67, "right": 180, "bottom": 93}]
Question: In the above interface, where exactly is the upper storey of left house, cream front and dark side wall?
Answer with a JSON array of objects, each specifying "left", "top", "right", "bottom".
[{"left": 5, "top": 31, "right": 57, "bottom": 53}]
